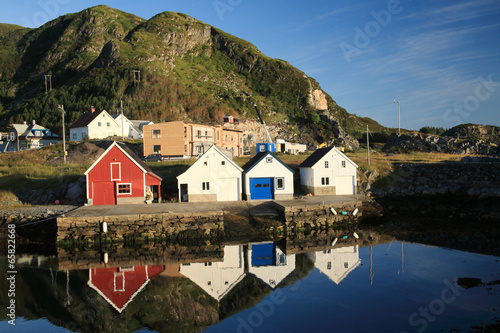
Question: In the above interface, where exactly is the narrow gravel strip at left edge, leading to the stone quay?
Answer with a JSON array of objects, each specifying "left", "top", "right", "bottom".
[{"left": 0, "top": 205, "right": 79, "bottom": 222}]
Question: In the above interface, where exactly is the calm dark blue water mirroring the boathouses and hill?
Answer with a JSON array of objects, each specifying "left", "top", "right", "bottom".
[{"left": 0, "top": 237, "right": 500, "bottom": 333}]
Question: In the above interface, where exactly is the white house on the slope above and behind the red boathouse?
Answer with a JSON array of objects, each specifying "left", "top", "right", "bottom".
[{"left": 69, "top": 108, "right": 122, "bottom": 141}]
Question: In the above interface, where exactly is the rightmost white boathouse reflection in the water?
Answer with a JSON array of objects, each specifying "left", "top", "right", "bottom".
[{"left": 307, "top": 245, "right": 361, "bottom": 284}]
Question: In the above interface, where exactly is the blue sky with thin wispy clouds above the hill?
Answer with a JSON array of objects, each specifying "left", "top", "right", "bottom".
[{"left": 0, "top": 0, "right": 500, "bottom": 130}]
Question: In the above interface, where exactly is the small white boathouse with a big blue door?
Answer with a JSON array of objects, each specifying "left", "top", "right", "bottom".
[{"left": 243, "top": 152, "right": 294, "bottom": 200}]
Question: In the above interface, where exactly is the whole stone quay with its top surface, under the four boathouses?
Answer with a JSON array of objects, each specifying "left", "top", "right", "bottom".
[{"left": 57, "top": 195, "right": 362, "bottom": 242}]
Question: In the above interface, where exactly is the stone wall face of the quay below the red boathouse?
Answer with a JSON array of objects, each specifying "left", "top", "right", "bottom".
[{"left": 57, "top": 212, "right": 224, "bottom": 242}]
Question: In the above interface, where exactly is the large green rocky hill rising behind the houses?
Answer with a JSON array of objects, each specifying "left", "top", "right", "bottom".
[{"left": 0, "top": 6, "right": 384, "bottom": 145}]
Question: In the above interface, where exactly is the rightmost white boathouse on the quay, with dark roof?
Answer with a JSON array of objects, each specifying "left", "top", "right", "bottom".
[{"left": 299, "top": 147, "right": 358, "bottom": 195}]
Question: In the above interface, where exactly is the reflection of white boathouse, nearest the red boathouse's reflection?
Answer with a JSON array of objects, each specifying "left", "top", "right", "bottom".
[{"left": 180, "top": 245, "right": 245, "bottom": 301}]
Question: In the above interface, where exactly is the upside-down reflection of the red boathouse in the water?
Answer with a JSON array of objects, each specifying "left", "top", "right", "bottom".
[{"left": 87, "top": 266, "right": 163, "bottom": 313}]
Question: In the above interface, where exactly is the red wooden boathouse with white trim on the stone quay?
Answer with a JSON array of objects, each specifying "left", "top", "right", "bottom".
[{"left": 85, "top": 142, "right": 162, "bottom": 206}]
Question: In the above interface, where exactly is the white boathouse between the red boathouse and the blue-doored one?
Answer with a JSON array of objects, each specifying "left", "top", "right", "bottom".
[{"left": 177, "top": 145, "right": 243, "bottom": 202}]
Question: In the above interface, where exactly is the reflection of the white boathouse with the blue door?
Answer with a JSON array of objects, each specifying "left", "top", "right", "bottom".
[{"left": 247, "top": 243, "right": 295, "bottom": 289}]
